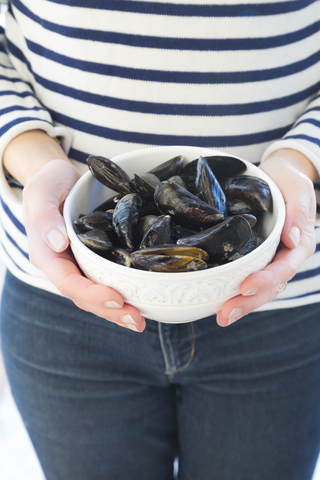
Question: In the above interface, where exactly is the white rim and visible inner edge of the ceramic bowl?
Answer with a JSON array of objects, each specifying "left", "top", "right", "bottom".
[{"left": 63, "top": 146, "right": 285, "bottom": 283}]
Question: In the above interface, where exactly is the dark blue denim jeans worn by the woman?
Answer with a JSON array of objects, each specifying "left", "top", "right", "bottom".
[{"left": 1, "top": 274, "right": 320, "bottom": 480}]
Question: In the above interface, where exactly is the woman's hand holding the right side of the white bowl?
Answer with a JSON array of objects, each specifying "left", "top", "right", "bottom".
[{"left": 217, "top": 149, "right": 317, "bottom": 327}]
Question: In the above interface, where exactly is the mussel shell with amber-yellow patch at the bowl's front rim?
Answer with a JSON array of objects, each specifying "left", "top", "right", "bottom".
[{"left": 131, "top": 254, "right": 207, "bottom": 273}]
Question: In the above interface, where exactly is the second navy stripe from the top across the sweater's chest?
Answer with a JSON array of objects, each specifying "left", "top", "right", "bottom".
[{"left": 14, "top": 0, "right": 320, "bottom": 51}]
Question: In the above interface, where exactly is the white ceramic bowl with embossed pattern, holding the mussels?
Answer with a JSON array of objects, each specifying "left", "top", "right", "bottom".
[{"left": 64, "top": 146, "right": 285, "bottom": 323}]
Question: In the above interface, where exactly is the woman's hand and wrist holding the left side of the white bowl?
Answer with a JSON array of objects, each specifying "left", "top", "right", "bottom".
[{"left": 5, "top": 132, "right": 145, "bottom": 332}]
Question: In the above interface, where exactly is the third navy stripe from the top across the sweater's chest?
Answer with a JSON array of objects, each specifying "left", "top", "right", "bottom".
[{"left": 25, "top": 40, "right": 320, "bottom": 84}]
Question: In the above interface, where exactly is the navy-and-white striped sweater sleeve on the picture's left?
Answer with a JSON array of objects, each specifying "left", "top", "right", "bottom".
[{"left": 0, "top": 7, "right": 71, "bottom": 203}]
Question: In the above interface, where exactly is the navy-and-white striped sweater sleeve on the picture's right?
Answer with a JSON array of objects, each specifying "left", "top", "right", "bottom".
[{"left": 261, "top": 92, "right": 320, "bottom": 226}]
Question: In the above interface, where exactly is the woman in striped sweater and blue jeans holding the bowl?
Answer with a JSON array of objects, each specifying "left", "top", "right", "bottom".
[{"left": 0, "top": 0, "right": 320, "bottom": 480}]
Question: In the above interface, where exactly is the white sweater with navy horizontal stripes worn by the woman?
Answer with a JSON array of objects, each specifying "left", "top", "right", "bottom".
[{"left": 0, "top": 0, "right": 320, "bottom": 309}]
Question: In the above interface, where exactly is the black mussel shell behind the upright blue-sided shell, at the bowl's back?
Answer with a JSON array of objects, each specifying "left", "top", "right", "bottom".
[{"left": 180, "top": 155, "right": 247, "bottom": 193}]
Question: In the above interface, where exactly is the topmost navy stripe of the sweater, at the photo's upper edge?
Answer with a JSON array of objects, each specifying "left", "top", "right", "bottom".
[{"left": 37, "top": 0, "right": 315, "bottom": 17}]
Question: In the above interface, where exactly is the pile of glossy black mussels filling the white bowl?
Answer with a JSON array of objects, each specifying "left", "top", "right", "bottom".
[{"left": 74, "top": 155, "right": 272, "bottom": 272}]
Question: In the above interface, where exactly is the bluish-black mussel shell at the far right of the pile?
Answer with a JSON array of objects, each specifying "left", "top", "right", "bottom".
[{"left": 224, "top": 175, "right": 272, "bottom": 212}]
